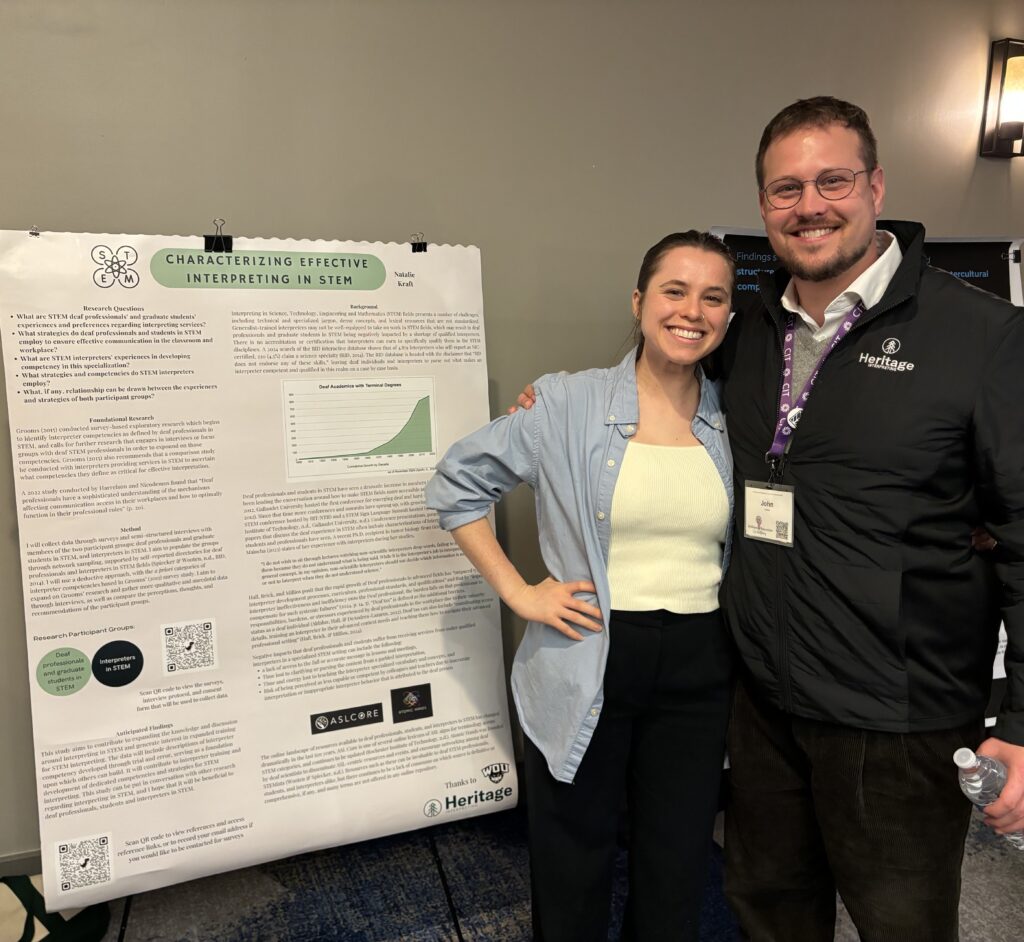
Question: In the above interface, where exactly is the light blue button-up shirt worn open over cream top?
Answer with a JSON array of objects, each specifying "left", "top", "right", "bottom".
[{"left": 426, "top": 349, "right": 733, "bottom": 782}]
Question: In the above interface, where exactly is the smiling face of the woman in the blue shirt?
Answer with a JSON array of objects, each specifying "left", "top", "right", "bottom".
[{"left": 633, "top": 246, "right": 732, "bottom": 373}]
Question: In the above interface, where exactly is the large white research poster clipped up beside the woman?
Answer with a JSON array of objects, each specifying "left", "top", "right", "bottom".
[{"left": 0, "top": 231, "right": 517, "bottom": 909}]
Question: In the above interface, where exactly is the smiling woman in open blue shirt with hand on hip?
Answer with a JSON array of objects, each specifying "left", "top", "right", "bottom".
[{"left": 427, "top": 230, "right": 735, "bottom": 942}]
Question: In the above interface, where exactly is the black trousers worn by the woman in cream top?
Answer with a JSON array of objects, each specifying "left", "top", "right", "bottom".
[{"left": 525, "top": 611, "right": 732, "bottom": 942}]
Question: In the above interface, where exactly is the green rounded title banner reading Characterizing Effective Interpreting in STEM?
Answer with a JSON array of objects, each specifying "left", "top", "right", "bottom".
[{"left": 150, "top": 249, "right": 385, "bottom": 291}]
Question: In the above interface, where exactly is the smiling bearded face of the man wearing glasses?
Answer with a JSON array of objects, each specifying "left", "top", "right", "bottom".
[{"left": 761, "top": 124, "right": 886, "bottom": 295}]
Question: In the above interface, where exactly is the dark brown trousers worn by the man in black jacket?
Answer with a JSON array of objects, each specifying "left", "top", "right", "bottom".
[{"left": 725, "top": 677, "right": 984, "bottom": 942}]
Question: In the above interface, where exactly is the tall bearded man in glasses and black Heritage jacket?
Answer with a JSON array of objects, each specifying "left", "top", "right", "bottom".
[{"left": 722, "top": 97, "right": 1024, "bottom": 942}]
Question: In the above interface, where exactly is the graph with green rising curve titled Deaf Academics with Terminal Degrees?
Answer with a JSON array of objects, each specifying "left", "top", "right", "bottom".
[{"left": 283, "top": 376, "right": 435, "bottom": 479}]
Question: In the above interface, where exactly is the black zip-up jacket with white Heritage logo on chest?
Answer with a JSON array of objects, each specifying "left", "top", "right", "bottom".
[{"left": 722, "top": 222, "right": 1024, "bottom": 744}]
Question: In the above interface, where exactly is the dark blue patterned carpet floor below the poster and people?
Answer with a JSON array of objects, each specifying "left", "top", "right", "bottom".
[{"left": 8, "top": 809, "right": 1024, "bottom": 942}]
